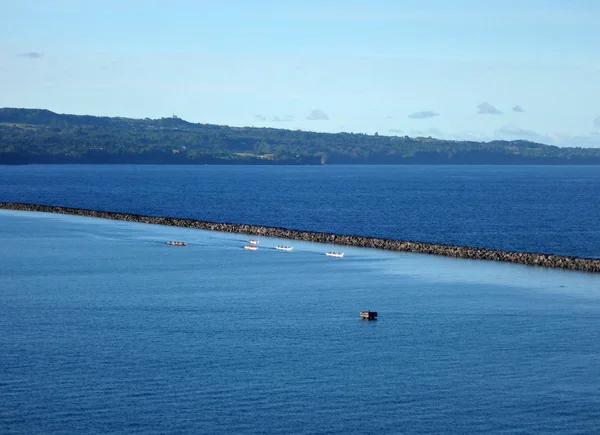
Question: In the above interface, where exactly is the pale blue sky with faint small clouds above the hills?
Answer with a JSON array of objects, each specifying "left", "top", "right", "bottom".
[{"left": 0, "top": 0, "right": 600, "bottom": 147}]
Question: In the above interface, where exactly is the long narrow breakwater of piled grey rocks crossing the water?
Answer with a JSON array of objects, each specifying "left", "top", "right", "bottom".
[{"left": 0, "top": 202, "right": 600, "bottom": 273}]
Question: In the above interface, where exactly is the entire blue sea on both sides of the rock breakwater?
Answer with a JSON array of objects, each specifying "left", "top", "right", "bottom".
[{"left": 0, "top": 166, "right": 600, "bottom": 434}]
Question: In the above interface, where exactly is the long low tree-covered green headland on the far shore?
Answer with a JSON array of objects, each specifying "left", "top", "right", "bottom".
[{"left": 0, "top": 108, "right": 600, "bottom": 165}]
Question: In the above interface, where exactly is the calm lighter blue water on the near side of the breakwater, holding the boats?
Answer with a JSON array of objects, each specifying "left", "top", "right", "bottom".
[{"left": 0, "top": 209, "right": 600, "bottom": 434}]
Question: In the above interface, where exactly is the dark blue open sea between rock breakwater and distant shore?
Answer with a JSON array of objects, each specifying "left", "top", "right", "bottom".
[{"left": 0, "top": 165, "right": 600, "bottom": 257}]
